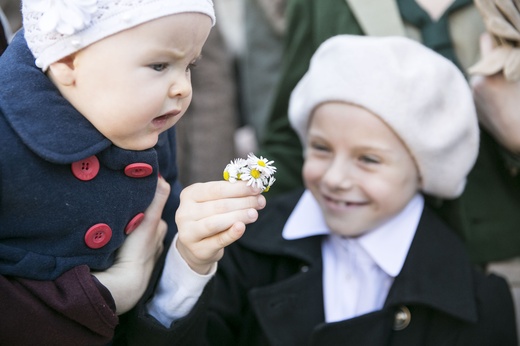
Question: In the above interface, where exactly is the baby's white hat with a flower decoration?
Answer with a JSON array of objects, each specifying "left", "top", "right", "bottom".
[{"left": 22, "top": 0, "right": 215, "bottom": 71}]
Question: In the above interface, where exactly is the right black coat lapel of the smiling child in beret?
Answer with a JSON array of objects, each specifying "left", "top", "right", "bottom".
[{"left": 385, "top": 208, "right": 477, "bottom": 322}]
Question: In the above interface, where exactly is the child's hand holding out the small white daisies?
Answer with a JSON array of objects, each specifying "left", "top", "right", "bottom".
[{"left": 176, "top": 181, "right": 266, "bottom": 274}]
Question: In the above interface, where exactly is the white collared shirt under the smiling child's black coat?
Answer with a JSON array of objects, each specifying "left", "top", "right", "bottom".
[{"left": 283, "top": 190, "right": 424, "bottom": 322}]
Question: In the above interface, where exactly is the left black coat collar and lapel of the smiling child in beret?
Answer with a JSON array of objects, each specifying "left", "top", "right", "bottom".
[{"left": 239, "top": 190, "right": 325, "bottom": 345}]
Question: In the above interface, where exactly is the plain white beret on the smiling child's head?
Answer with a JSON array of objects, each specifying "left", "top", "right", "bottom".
[{"left": 289, "top": 35, "right": 479, "bottom": 198}]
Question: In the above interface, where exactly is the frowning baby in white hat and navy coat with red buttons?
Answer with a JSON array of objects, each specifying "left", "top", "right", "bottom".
[{"left": 0, "top": 0, "right": 214, "bottom": 280}]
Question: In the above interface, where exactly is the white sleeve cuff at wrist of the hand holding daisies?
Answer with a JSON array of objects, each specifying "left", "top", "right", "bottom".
[{"left": 147, "top": 235, "right": 217, "bottom": 328}]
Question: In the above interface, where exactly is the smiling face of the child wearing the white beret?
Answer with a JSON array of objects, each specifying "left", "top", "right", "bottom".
[{"left": 303, "top": 102, "right": 420, "bottom": 237}]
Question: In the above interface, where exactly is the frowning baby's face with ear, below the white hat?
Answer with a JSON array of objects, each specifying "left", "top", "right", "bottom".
[{"left": 60, "top": 13, "right": 211, "bottom": 150}]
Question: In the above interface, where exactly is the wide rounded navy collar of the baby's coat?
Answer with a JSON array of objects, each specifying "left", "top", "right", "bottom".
[{"left": 0, "top": 31, "right": 111, "bottom": 164}]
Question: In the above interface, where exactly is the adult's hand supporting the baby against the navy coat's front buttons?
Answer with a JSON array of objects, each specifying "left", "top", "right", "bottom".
[{"left": 92, "top": 178, "right": 170, "bottom": 315}]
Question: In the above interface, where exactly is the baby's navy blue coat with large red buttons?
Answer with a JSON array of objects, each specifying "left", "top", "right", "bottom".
[{"left": 0, "top": 32, "right": 180, "bottom": 280}]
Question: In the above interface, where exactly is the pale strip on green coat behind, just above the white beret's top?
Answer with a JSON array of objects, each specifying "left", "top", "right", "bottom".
[{"left": 345, "top": 0, "right": 405, "bottom": 36}]
